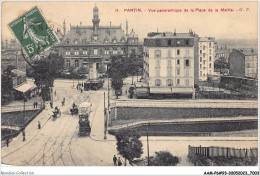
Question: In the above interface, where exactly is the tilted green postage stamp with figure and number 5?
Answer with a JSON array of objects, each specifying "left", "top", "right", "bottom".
[{"left": 9, "top": 6, "right": 58, "bottom": 59}]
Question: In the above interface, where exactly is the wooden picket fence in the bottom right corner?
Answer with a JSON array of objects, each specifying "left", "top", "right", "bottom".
[{"left": 188, "top": 145, "right": 258, "bottom": 158}]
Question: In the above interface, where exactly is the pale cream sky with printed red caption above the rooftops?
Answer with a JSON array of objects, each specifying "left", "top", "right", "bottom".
[{"left": 1, "top": 1, "right": 258, "bottom": 40}]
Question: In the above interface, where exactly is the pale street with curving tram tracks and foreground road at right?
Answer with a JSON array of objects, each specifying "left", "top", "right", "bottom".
[{"left": 1, "top": 80, "right": 258, "bottom": 166}]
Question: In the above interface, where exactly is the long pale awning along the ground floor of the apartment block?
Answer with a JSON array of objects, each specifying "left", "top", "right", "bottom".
[{"left": 150, "top": 87, "right": 193, "bottom": 94}]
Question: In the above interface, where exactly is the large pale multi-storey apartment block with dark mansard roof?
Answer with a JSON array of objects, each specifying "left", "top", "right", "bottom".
[{"left": 143, "top": 31, "right": 195, "bottom": 98}]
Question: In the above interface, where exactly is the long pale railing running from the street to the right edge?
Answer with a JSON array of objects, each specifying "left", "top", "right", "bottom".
[{"left": 111, "top": 101, "right": 258, "bottom": 108}]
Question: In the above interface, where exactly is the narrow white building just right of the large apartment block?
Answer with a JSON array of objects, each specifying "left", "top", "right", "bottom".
[{"left": 199, "top": 37, "right": 215, "bottom": 81}]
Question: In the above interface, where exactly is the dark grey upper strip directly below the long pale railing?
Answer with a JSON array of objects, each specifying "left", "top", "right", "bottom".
[{"left": 114, "top": 107, "right": 258, "bottom": 120}]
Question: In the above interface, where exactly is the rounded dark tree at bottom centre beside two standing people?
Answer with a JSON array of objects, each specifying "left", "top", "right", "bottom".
[{"left": 116, "top": 130, "right": 143, "bottom": 165}]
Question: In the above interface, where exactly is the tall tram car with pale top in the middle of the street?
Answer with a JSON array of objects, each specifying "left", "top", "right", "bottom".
[{"left": 79, "top": 102, "right": 92, "bottom": 136}]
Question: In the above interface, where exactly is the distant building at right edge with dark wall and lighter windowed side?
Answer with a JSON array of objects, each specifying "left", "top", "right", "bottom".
[{"left": 229, "top": 49, "right": 258, "bottom": 78}]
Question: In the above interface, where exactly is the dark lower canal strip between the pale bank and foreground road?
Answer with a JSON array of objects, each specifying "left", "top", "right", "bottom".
[{"left": 109, "top": 119, "right": 258, "bottom": 136}]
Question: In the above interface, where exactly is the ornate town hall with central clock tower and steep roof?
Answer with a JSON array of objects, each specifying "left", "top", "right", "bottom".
[{"left": 55, "top": 6, "right": 142, "bottom": 79}]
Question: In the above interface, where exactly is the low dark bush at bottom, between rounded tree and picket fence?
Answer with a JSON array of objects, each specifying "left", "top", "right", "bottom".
[{"left": 149, "top": 151, "right": 180, "bottom": 166}]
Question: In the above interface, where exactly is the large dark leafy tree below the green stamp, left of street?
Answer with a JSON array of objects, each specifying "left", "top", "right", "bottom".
[{"left": 32, "top": 52, "right": 64, "bottom": 101}]
